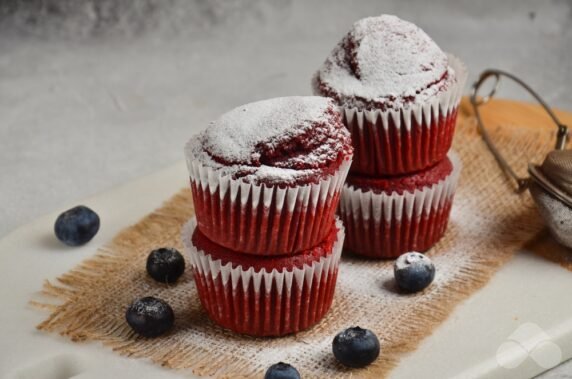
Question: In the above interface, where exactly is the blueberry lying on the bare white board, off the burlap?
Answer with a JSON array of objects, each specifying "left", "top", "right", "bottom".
[{"left": 54, "top": 205, "right": 99, "bottom": 246}]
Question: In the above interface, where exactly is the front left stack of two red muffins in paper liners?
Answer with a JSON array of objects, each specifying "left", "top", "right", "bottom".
[{"left": 183, "top": 97, "right": 353, "bottom": 336}]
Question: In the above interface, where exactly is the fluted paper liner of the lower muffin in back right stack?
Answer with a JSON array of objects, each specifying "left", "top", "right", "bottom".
[{"left": 339, "top": 152, "right": 462, "bottom": 258}]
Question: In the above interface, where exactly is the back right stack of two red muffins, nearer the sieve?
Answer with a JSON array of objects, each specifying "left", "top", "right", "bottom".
[{"left": 313, "top": 15, "right": 467, "bottom": 258}]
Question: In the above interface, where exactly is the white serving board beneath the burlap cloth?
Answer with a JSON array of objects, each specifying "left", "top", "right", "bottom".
[{"left": 0, "top": 162, "right": 572, "bottom": 379}]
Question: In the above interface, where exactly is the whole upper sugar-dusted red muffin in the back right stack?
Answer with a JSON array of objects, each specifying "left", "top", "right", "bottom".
[{"left": 313, "top": 15, "right": 467, "bottom": 176}]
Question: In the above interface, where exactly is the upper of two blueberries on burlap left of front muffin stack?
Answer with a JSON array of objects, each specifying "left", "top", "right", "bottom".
[{"left": 147, "top": 247, "right": 185, "bottom": 283}]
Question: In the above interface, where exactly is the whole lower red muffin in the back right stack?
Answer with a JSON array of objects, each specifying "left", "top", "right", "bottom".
[{"left": 339, "top": 153, "right": 461, "bottom": 258}]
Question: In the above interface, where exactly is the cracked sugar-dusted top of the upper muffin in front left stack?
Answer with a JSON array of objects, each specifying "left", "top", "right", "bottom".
[{"left": 186, "top": 96, "right": 352, "bottom": 185}]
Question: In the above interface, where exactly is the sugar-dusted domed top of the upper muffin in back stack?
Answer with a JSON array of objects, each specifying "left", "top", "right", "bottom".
[{"left": 313, "top": 15, "right": 455, "bottom": 110}]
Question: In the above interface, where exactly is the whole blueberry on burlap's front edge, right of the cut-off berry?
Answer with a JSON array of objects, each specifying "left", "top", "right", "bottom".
[{"left": 332, "top": 326, "right": 380, "bottom": 368}]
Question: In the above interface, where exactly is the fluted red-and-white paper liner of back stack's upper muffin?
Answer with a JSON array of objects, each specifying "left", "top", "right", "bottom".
[{"left": 328, "top": 54, "right": 467, "bottom": 176}]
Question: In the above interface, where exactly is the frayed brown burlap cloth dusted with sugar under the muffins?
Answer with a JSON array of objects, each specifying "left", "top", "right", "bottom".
[{"left": 35, "top": 99, "right": 564, "bottom": 378}]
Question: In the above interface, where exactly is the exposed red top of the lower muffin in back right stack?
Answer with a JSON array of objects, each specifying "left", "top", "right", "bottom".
[{"left": 347, "top": 158, "right": 453, "bottom": 195}]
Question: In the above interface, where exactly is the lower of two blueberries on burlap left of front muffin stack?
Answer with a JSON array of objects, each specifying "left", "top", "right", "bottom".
[{"left": 125, "top": 297, "right": 175, "bottom": 337}]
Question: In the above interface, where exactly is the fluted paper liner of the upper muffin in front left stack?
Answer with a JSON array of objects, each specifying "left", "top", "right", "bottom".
[{"left": 187, "top": 154, "right": 351, "bottom": 255}]
